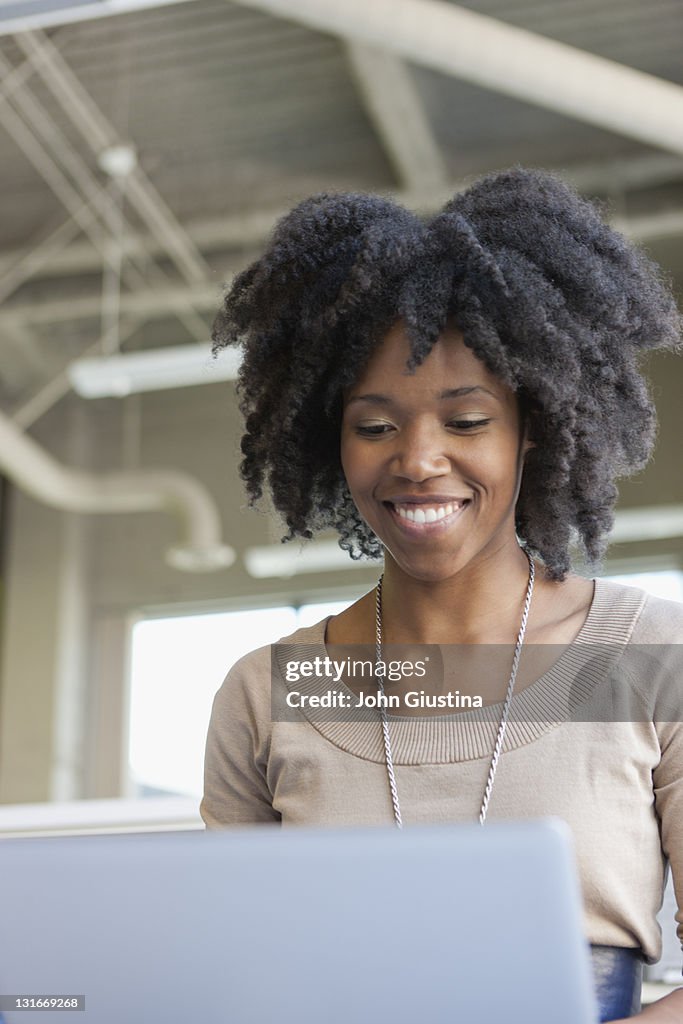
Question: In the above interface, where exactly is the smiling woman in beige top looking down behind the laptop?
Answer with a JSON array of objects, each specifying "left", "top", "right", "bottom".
[{"left": 202, "top": 169, "right": 683, "bottom": 1022}]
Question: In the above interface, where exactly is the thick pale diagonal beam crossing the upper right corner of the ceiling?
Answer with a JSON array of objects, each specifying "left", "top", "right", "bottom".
[{"left": 232, "top": 0, "right": 683, "bottom": 155}]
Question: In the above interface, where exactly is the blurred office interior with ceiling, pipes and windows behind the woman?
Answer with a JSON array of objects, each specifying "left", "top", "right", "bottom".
[{"left": 0, "top": 0, "right": 683, "bottom": 974}]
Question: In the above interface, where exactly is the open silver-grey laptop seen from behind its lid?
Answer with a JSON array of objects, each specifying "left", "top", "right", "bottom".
[{"left": 0, "top": 820, "right": 597, "bottom": 1024}]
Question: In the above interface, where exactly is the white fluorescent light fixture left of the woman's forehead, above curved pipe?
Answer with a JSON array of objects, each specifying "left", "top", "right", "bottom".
[{"left": 68, "top": 344, "right": 242, "bottom": 398}]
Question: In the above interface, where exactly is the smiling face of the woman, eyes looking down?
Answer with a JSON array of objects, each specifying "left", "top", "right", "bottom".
[{"left": 341, "top": 323, "right": 531, "bottom": 581}]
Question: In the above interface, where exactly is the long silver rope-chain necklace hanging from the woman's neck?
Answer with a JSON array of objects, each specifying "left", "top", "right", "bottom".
[{"left": 375, "top": 551, "right": 536, "bottom": 828}]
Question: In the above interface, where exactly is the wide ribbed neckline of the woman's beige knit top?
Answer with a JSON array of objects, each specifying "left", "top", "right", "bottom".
[{"left": 273, "top": 580, "right": 647, "bottom": 765}]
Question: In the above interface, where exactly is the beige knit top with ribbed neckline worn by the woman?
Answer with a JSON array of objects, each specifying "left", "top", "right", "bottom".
[{"left": 201, "top": 580, "right": 683, "bottom": 961}]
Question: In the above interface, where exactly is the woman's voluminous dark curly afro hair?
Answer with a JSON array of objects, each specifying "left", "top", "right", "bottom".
[{"left": 213, "top": 168, "right": 681, "bottom": 581}]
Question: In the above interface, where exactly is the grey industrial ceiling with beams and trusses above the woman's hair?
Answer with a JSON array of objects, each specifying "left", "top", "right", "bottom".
[{"left": 0, "top": 0, "right": 683, "bottom": 428}]
